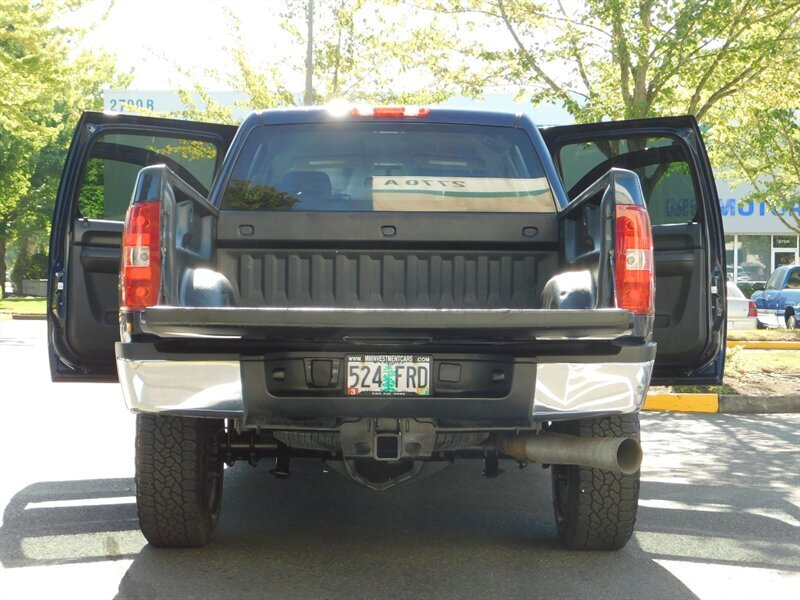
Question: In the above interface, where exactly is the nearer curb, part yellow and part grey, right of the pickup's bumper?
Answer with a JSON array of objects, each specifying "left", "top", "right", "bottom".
[{"left": 642, "top": 394, "right": 800, "bottom": 414}]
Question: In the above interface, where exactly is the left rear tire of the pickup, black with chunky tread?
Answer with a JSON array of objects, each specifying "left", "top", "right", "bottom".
[{"left": 136, "top": 414, "right": 224, "bottom": 548}]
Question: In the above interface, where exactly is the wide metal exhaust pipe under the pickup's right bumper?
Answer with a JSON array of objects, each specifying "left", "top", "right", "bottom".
[{"left": 497, "top": 432, "right": 642, "bottom": 475}]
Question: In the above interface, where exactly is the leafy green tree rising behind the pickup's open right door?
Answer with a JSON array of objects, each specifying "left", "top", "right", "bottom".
[{"left": 418, "top": 0, "right": 800, "bottom": 230}]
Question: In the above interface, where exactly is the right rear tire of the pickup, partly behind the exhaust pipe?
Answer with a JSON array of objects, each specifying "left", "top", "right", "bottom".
[{"left": 551, "top": 414, "right": 640, "bottom": 550}]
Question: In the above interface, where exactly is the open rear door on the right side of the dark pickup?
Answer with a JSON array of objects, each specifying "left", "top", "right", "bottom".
[{"left": 541, "top": 116, "right": 725, "bottom": 385}]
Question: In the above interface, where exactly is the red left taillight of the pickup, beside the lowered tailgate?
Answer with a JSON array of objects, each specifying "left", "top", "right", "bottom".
[{"left": 119, "top": 202, "right": 161, "bottom": 310}]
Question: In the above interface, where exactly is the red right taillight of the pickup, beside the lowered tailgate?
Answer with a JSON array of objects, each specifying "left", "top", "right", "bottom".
[{"left": 614, "top": 204, "right": 655, "bottom": 315}]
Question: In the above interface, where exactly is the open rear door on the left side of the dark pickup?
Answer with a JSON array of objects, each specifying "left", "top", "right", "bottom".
[{"left": 47, "top": 112, "right": 237, "bottom": 381}]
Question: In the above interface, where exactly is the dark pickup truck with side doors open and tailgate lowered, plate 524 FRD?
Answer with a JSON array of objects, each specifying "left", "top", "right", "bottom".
[{"left": 48, "top": 107, "right": 726, "bottom": 549}]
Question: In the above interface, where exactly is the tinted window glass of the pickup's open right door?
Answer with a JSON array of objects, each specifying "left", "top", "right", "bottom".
[{"left": 558, "top": 137, "right": 699, "bottom": 225}]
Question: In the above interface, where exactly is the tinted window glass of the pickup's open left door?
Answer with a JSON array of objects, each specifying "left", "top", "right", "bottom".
[{"left": 78, "top": 133, "right": 219, "bottom": 221}]
